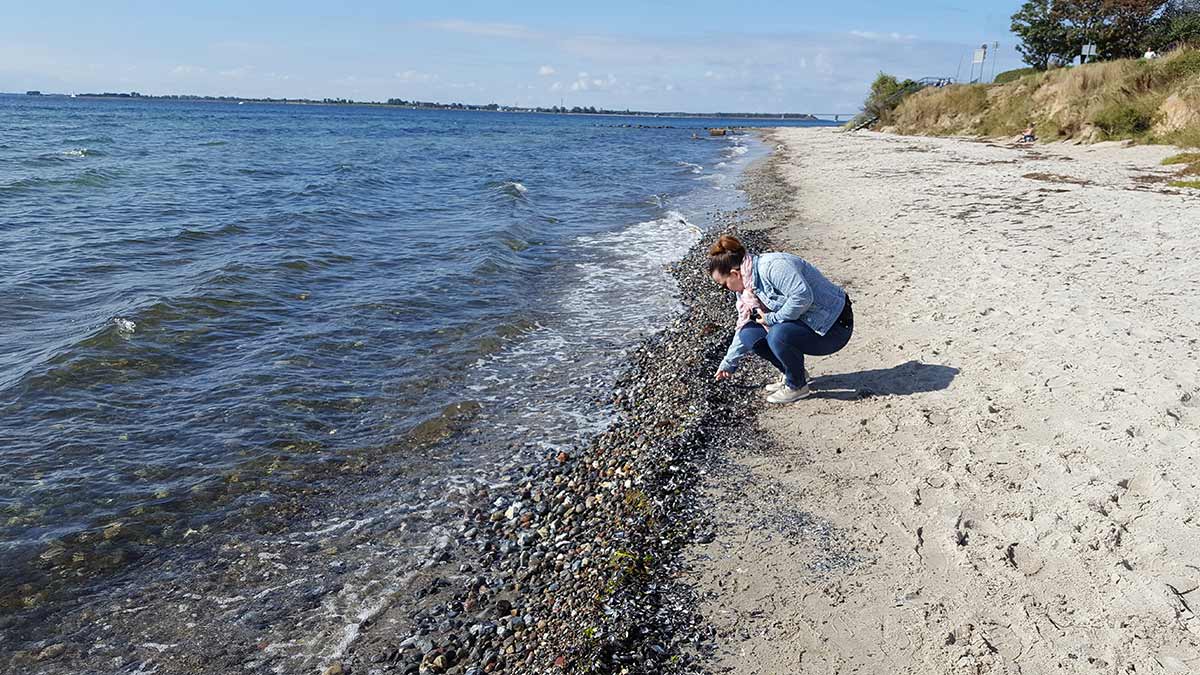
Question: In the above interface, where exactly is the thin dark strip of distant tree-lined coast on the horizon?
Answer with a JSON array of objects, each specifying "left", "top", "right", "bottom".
[{"left": 13, "top": 90, "right": 830, "bottom": 121}]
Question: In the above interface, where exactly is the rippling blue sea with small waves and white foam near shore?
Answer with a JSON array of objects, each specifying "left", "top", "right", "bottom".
[{"left": 0, "top": 96, "right": 835, "bottom": 609}]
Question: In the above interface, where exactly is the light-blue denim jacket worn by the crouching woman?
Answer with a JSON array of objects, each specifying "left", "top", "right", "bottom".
[{"left": 720, "top": 253, "right": 846, "bottom": 372}]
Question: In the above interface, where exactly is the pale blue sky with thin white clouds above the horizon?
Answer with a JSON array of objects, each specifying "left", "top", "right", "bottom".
[{"left": 0, "top": 0, "right": 1021, "bottom": 113}]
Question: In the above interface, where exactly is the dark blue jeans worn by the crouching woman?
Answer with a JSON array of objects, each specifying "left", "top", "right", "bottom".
[{"left": 738, "top": 304, "right": 854, "bottom": 389}]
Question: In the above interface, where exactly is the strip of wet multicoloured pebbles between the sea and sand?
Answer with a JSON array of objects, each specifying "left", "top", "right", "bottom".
[{"left": 343, "top": 149, "right": 787, "bottom": 675}]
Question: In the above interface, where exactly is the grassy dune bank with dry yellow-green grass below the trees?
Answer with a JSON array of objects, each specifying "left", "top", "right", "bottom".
[{"left": 882, "top": 49, "right": 1200, "bottom": 147}]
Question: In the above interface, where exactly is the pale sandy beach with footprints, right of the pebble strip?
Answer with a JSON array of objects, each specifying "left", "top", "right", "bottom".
[{"left": 688, "top": 130, "right": 1200, "bottom": 674}]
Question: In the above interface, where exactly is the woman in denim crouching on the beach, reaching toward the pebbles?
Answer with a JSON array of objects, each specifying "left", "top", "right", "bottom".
[{"left": 708, "top": 235, "right": 854, "bottom": 404}]
